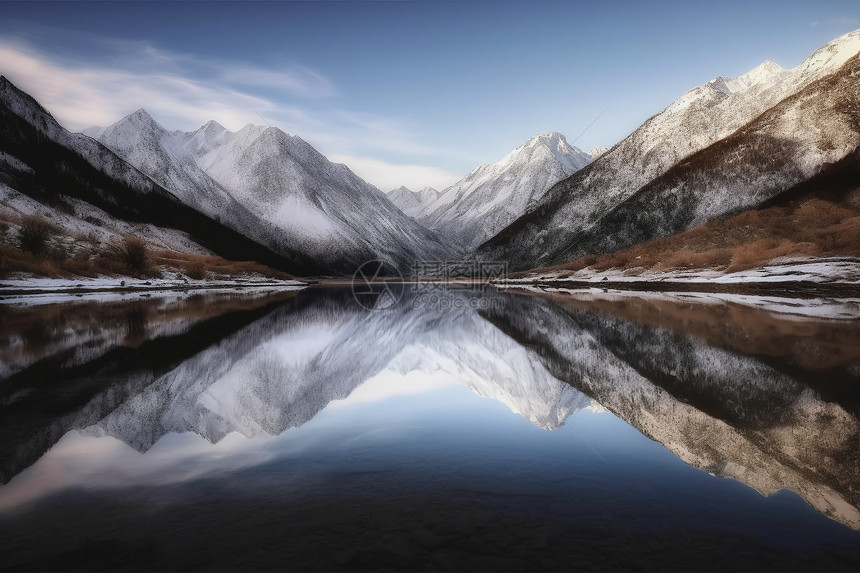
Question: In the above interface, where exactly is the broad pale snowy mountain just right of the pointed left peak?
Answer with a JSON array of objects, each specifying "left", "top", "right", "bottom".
[{"left": 185, "top": 125, "right": 451, "bottom": 273}]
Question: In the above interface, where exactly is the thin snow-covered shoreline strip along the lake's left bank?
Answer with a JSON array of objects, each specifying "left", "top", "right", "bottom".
[{"left": 0, "top": 273, "right": 307, "bottom": 305}]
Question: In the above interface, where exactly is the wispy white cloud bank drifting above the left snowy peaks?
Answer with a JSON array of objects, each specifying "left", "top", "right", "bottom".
[{"left": 0, "top": 38, "right": 457, "bottom": 189}]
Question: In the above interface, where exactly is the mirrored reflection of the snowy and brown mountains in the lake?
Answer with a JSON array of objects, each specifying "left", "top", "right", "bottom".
[{"left": 0, "top": 288, "right": 860, "bottom": 528}]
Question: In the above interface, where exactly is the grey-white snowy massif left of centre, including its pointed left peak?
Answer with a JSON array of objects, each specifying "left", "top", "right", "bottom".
[{"left": 89, "top": 114, "right": 452, "bottom": 274}]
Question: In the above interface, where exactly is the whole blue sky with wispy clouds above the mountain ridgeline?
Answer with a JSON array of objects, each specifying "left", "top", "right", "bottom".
[{"left": 0, "top": 0, "right": 860, "bottom": 190}]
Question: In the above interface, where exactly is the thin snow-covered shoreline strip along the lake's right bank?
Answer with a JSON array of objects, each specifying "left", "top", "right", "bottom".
[{"left": 493, "top": 257, "right": 860, "bottom": 288}]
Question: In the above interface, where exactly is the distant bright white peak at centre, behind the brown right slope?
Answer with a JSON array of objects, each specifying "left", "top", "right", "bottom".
[{"left": 416, "top": 132, "right": 591, "bottom": 248}]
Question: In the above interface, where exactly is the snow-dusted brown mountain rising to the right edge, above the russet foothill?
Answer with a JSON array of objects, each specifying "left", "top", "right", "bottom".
[{"left": 479, "top": 30, "right": 860, "bottom": 269}]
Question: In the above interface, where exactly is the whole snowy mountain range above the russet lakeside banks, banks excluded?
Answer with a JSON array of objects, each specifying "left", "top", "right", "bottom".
[{"left": 0, "top": 31, "right": 860, "bottom": 276}]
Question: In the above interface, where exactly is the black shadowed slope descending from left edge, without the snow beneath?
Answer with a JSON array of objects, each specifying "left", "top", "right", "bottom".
[{"left": 0, "top": 77, "right": 298, "bottom": 268}]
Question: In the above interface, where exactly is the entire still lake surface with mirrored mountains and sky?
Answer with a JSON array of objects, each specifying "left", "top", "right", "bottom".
[{"left": 0, "top": 285, "right": 860, "bottom": 571}]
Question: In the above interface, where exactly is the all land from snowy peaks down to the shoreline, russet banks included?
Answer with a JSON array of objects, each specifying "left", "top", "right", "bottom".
[{"left": 0, "top": 30, "right": 860, "bottom": 288}]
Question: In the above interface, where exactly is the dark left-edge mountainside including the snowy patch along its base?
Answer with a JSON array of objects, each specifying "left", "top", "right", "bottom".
[{"left": 0, "top": 77, "right": 285, "bottom": 266}]
